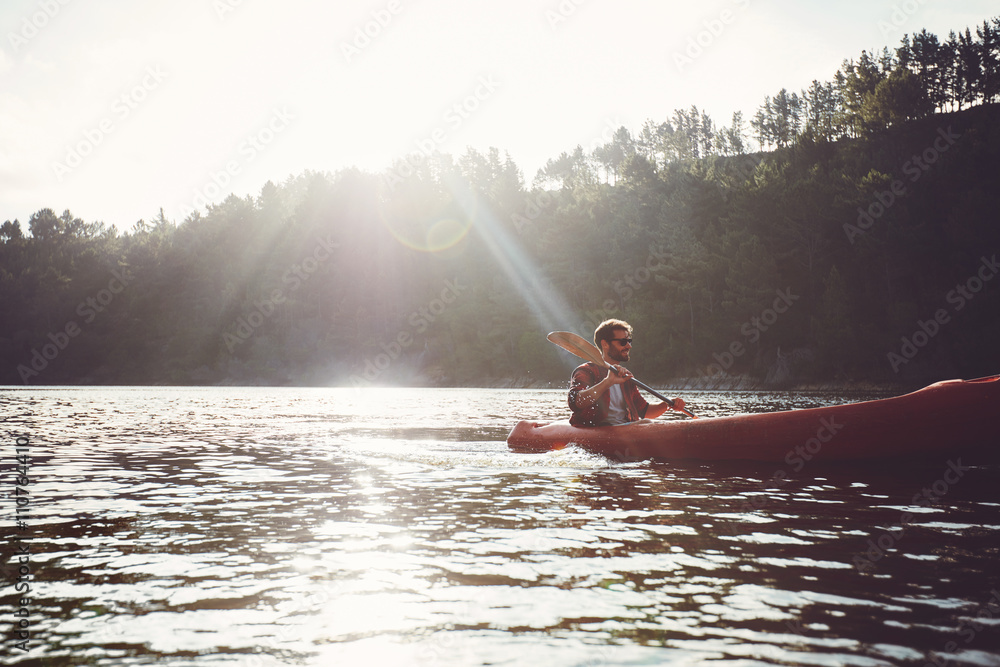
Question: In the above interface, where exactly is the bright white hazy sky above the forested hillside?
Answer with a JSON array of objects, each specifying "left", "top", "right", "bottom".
[{"left": 0, "top": 0, "right": 1000, "bottom": 229}]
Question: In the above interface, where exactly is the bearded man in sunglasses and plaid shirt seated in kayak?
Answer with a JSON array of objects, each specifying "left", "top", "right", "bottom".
[{"left": 569, "top": 320, "right": 684, "bottom": 426}]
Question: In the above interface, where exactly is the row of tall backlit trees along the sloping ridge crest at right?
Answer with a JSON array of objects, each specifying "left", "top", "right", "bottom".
[{"left": 564, "top": 18, "right": 1000, "bottom": 180}]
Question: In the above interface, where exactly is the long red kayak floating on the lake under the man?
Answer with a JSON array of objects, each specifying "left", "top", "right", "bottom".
[{"left": 507, "top": 375, "right": 1000, "bottom": 464}]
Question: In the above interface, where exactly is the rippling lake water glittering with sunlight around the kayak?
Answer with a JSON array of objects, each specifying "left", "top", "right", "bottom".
[{"left": 0, "top": 388, "right": 1000, "bottom": 667}]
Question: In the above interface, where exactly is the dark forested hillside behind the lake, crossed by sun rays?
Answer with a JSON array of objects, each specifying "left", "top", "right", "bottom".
[{"left": 0, "top": 19, "right": 1000, "bottom": 386}]
